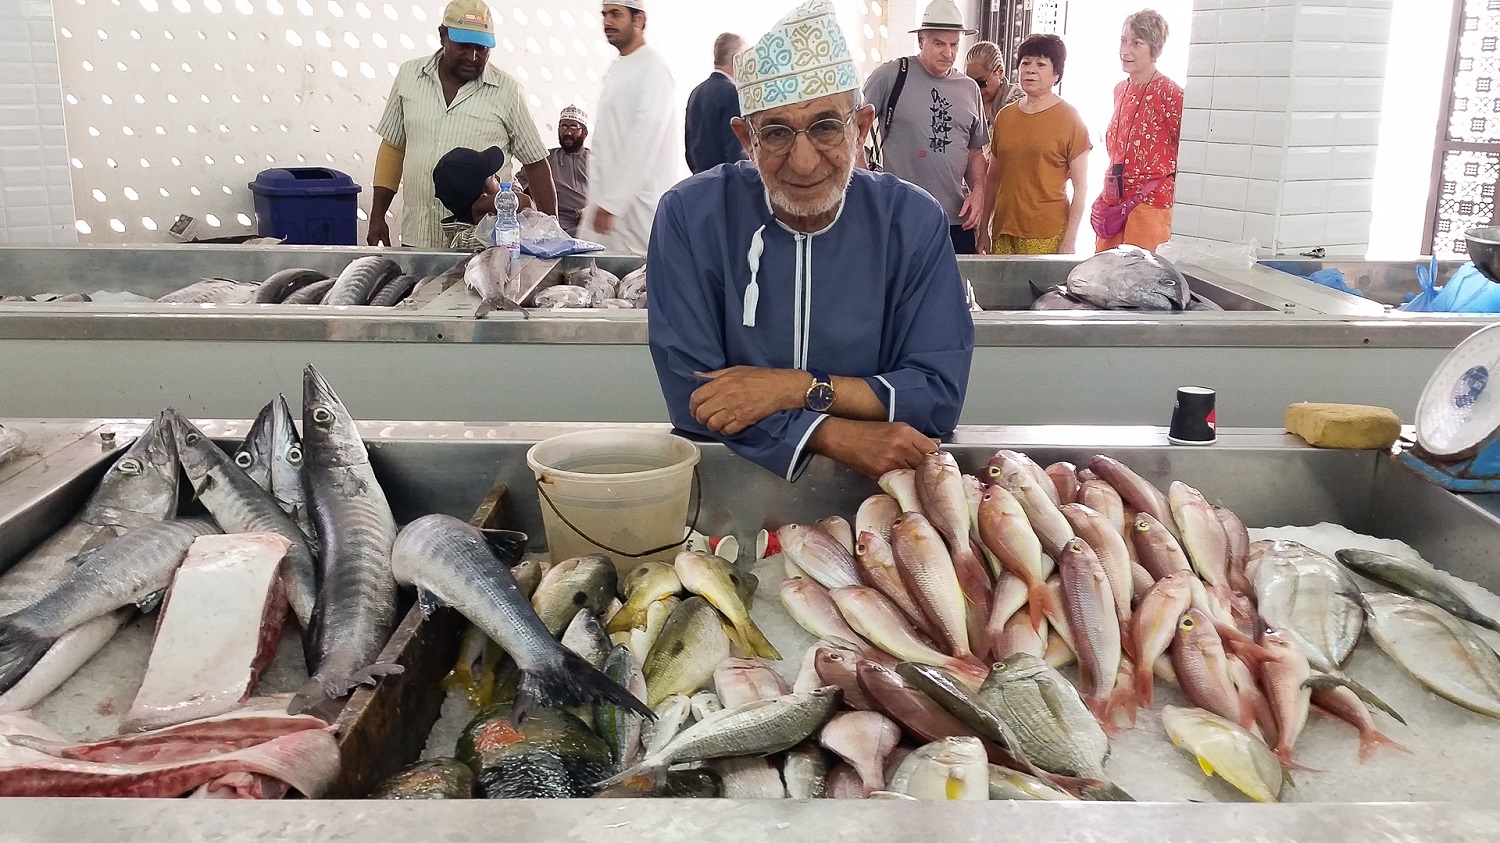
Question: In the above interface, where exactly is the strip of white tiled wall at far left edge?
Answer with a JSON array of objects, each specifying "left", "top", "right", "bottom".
[{"left": 0, "top": 0, "right": 77, "bottom": 245}]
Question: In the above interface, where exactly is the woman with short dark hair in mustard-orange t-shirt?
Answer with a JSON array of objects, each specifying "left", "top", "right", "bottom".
[{"left": 980, "top": 35, "right": 1094, "bottom": 255}]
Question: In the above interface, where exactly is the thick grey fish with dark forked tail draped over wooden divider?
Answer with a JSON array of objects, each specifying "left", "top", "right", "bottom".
[{"left": 390, "top": 515, "right": 650, "bottom": 722}]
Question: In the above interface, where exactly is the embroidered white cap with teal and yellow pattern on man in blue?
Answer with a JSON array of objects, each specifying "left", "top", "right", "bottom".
[{"left": 735, "top": 0, "right": 860, "bottom": 116}]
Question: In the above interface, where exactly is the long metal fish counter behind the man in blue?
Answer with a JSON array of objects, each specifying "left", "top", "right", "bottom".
[{"left": 0, "top": 246, "right": 1488, "bottom": 426}]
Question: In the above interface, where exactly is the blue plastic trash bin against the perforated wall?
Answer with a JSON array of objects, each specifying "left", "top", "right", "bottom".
[{"left": 251, "top": 167, "right": 360, "bottom": 246}]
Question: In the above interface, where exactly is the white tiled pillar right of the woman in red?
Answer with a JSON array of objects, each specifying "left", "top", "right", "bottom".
[{"left": 1173, "top": 0, "right": 1392, "bottom": 257}]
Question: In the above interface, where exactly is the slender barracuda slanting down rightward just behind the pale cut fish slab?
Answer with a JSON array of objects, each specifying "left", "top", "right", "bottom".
[{"left": 174, "top": 416, "right": 318, "bottom": 630}]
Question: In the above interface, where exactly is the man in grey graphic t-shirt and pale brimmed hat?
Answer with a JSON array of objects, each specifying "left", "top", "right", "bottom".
[{"left": 864, "top": 0, "right": 990, "bottom": 255}]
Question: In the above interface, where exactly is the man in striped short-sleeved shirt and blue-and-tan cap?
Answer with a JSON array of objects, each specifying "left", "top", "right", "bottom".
[{"left": 368, "top": 0, "right": 557, "bottom": 249}]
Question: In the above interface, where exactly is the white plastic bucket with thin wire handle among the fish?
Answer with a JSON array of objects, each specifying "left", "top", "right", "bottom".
[{"left": 527, "top": 428, "right": 702, "bottom": 576}]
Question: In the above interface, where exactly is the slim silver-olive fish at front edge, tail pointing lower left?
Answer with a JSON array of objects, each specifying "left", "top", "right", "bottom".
[{"left": 599, "top": 687, "right": 839, "bottom": 788}]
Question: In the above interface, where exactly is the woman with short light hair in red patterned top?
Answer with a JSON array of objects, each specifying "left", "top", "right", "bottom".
[{"left": 1097, "top": 9, "right": 1182, "bottom": 252}]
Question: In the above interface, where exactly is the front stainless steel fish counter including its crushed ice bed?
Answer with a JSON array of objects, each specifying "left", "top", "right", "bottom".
[{"left": 0, "top": 417, "right": 1500, "bottom": 843}]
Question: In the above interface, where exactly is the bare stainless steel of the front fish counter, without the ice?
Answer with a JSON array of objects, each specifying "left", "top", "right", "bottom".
[{"left": 0, "top": 420, "right": 1500, "bottom": 843}]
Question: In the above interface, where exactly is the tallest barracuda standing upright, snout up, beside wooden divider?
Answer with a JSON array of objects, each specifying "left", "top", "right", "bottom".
[{"left": 291, "top": 366, "right": 402, "bottom": 713}]
